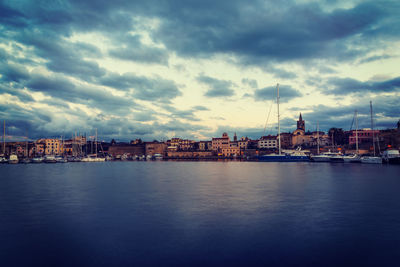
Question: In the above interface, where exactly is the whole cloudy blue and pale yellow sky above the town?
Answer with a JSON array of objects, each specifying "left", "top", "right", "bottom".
[{"left": 0, "top": 0, "right": 400, "bottom": 141}]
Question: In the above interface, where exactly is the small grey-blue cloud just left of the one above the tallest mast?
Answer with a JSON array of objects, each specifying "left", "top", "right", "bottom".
[{"left": 197, "top": 75, "right": 235, "bottom": 97}]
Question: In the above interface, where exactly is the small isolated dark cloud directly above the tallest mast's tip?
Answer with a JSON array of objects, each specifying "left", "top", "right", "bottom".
[{"left": 254, "top": 85, "right": 302, "bottom": 103}]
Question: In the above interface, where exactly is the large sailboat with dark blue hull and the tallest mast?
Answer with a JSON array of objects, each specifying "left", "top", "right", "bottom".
[{"left": 258, "top": 83, "right": 310, "bottom": 162}]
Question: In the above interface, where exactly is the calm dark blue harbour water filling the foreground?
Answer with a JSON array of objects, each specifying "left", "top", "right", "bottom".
[{"left": 0, "top": 162, "right": 400, "bottom": 266}]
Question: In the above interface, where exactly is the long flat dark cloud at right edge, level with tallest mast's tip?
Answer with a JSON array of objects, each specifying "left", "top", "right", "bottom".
[{"left": 323, "top": 77, "right": 400, "bottom": 95}]
